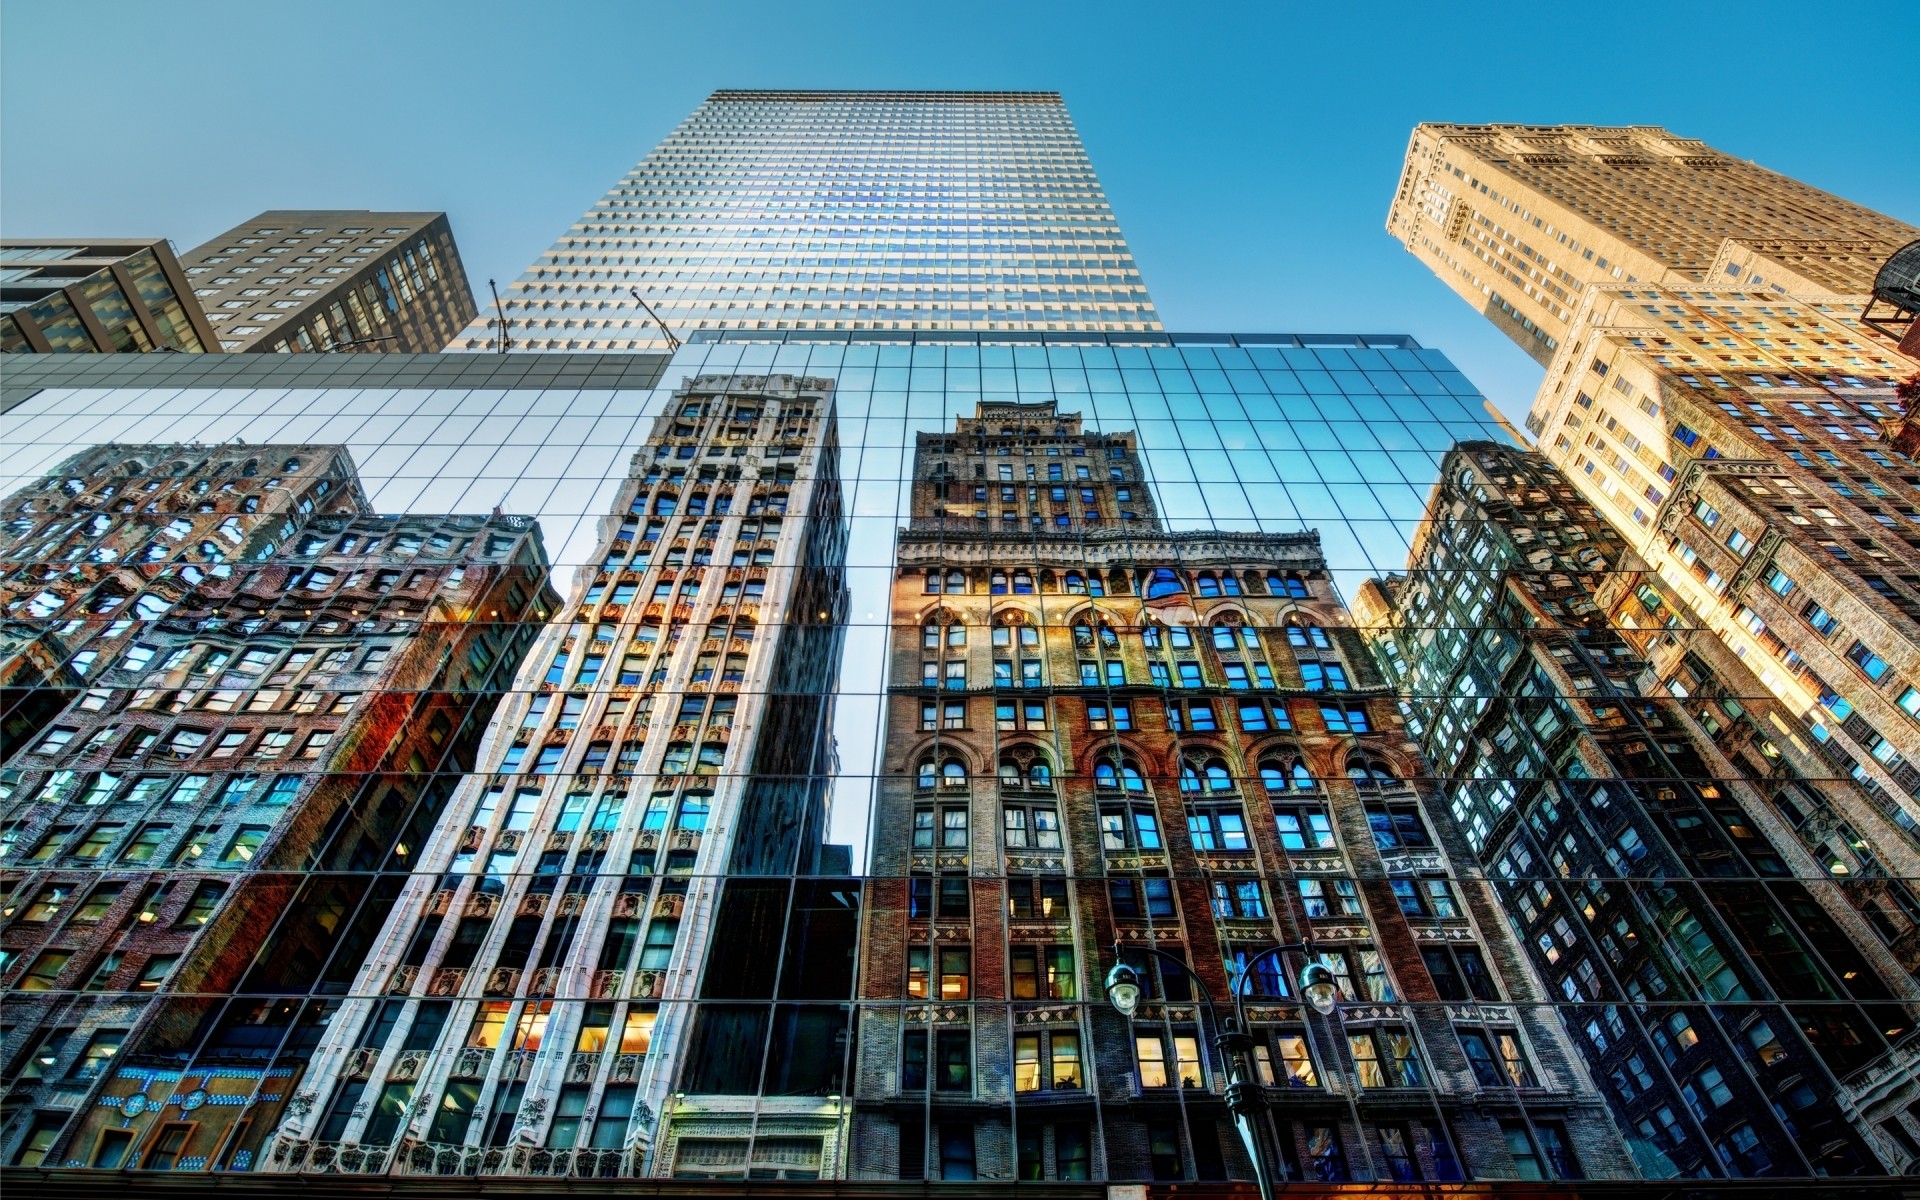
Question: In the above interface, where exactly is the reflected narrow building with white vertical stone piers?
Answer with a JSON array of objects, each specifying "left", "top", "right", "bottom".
[{"left": 261, "top": 374, "right": 858, "bottom": 1177}]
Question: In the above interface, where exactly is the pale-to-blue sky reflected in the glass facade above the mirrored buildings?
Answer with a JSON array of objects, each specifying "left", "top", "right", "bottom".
[{"left": 0, "top": 342, "right": 1505, "bottom": 864}]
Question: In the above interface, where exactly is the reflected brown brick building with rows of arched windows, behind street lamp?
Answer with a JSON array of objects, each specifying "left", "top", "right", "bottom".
[{"left": 849, "top": 401, "right": 1630, "bottom": 1181}]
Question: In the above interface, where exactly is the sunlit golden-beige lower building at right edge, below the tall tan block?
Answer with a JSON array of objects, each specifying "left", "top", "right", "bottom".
[{"left": 1528, "top": 286, "right": 1920, "bottom": 864}]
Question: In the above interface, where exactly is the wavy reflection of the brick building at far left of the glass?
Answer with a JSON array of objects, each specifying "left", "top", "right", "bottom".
[{"left": 0, "top": 445, "right": 553, "bottom": 1169}]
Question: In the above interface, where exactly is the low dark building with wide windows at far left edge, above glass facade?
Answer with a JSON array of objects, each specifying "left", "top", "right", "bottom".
[{"left": 0, "top": 238, "right": 219, "bottom": 353}]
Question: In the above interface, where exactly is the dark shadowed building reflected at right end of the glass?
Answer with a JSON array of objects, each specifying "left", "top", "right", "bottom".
[{"left": 1357, "top": 442, "right": 1920, "bottom": 1177}]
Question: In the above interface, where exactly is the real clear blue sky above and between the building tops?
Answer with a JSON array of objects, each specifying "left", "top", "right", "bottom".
[{"left": 0, "top": 0, "right": 1920, "bottom": 413}]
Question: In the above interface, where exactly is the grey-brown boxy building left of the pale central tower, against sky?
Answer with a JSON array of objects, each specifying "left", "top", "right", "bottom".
[{"left": 180, "top": 209, "right": 476, "bottom": 353}]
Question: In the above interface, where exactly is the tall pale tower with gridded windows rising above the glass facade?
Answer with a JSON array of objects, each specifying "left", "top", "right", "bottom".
[{"left": 449, "top": 90, "right": 1160, "bottom": 351}]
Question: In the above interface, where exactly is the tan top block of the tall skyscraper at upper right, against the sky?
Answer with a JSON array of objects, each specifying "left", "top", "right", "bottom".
[{"left": 1386, "top": 123, "right": 1920, "bottom": 365}]
